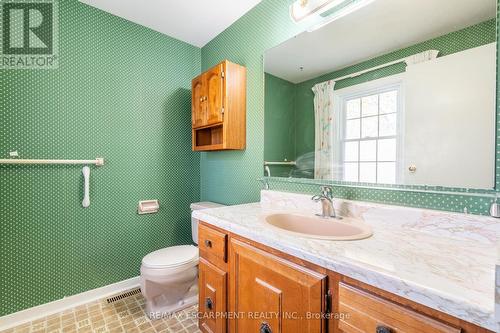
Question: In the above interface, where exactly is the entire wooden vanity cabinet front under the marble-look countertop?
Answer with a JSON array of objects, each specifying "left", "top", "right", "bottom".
[{"left": 199, "top": 222, "right": 493, "bottom": 333}]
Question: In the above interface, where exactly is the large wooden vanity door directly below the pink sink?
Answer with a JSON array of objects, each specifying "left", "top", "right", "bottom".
[{"left": 229, "top": 239, "right": 326, "bottom": 333}]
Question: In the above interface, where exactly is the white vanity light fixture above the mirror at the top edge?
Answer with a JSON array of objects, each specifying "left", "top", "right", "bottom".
[{"left": 290, "top": 0, "right": 375, "bottom": 32}]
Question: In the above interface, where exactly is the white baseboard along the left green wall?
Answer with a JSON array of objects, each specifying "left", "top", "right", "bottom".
[{"left": 0, "top": 276, "right": 139, "bottom": 331}]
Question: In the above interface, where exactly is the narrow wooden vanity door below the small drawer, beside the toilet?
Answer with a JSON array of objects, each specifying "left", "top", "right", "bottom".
[{"left": 198, "top": 258, "right": 227, "bottom": 333}]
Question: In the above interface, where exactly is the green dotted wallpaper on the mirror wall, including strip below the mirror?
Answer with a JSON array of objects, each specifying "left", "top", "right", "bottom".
[{"left": 201, "top": 0, "right": 500, "bottom": 214}]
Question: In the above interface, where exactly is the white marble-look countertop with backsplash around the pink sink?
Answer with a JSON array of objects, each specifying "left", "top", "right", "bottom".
[{"left": 193, "top": 191, "right": 500, "bottom": 331}]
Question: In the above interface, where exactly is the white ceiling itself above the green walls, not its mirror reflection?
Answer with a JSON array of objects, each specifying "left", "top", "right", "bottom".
[{"left": 80, "top": 0, "right": 261, "bottom": 47}]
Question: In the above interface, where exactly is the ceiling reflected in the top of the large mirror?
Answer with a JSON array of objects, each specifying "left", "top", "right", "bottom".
[{"left": 265, "top": 0, "right": 496, "bottom": 83}]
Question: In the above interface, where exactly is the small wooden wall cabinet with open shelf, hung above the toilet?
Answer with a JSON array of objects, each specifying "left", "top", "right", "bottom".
[{"left": 191, "top": 60, "right": 246, "bottom": 151}]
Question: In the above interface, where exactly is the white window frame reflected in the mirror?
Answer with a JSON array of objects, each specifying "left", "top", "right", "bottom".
[{"left": 333, "top": 78, "right": 404, "bottom": 185}]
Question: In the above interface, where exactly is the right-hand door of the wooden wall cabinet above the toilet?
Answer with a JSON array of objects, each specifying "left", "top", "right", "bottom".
[{"left": 203, "top": 64, "right": 224, "bottom": 125}]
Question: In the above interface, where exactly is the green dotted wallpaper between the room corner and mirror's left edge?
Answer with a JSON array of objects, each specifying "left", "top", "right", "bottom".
[{"left": 201, "top": 0, "right": 306, "bottom": 204}]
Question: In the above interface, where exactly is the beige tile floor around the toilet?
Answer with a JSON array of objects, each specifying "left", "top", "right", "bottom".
[{"left": 0, "top": 293, "right": 200, "bottom": 333}]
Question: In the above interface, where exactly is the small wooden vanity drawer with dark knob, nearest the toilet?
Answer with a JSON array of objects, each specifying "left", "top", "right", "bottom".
[{"left": 198, "top": 223, "right": 227, "bottom": 267}]
